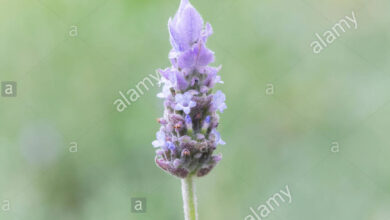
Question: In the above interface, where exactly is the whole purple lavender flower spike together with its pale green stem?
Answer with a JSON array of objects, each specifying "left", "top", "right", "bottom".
[{"left": 153, "top": 0, "right": 226, "bottom": 220}]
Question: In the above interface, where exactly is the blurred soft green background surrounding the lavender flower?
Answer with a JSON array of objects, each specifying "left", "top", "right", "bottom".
[{"left": 0, "top": 0, "right": 390, "bottom": 220}]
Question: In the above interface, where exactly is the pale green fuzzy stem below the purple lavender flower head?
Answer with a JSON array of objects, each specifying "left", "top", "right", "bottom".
[{"left": 181, "top": 176, "right": 198, "bottom": 220}]
